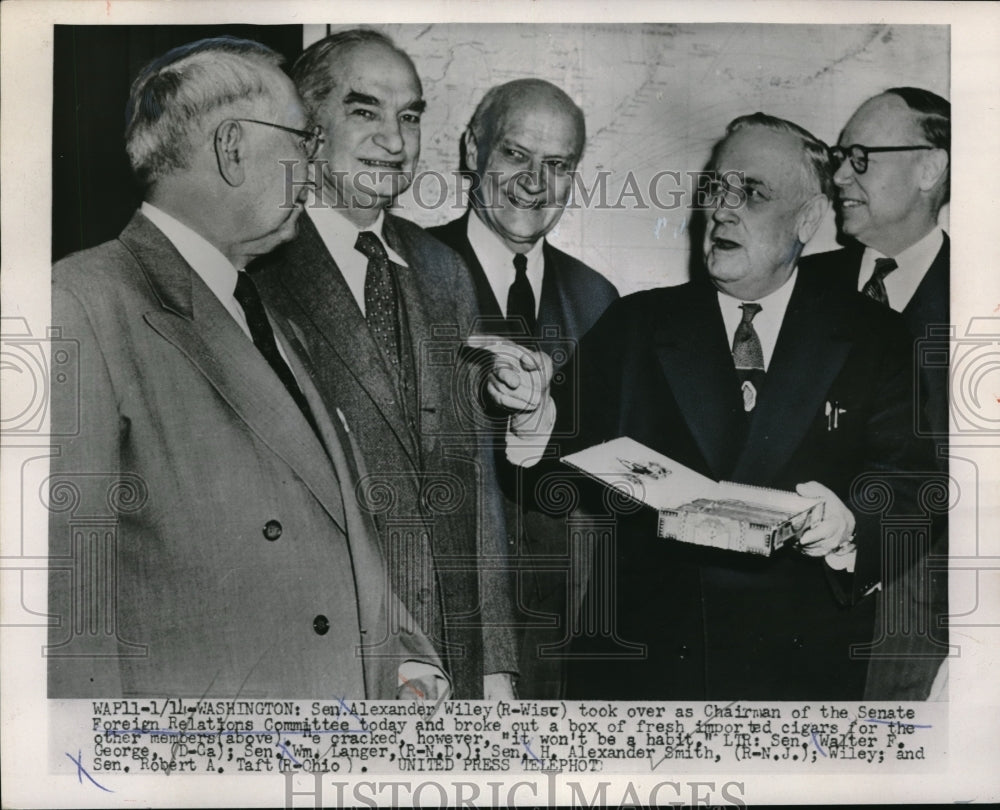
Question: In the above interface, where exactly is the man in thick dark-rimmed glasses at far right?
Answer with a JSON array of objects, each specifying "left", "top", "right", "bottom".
[{"left": 803, "top": 87, "right": 951, "bottom": 700}]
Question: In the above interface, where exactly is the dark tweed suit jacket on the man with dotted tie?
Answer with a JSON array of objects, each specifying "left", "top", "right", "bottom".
[{"left": 255, "top": 214, "right": 517, "bottom": 698}]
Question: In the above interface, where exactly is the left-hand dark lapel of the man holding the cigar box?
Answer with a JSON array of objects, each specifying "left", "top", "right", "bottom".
[{"left": 653, "top": 283, "right": 743, "bottom": 478}]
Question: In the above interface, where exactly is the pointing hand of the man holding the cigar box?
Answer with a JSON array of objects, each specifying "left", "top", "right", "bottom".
[{"left": 466, "top": 335, "right": 552, "bottom": 421}]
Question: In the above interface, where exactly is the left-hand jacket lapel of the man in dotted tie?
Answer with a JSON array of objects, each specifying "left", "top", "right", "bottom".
[{"left": 280, "top": 217, "right": 417, "bottom": 463}]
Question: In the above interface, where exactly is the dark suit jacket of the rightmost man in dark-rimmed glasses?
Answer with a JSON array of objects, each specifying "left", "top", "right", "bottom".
[{"left": 800, "top": 234, "right": 951, "bottom": 700}]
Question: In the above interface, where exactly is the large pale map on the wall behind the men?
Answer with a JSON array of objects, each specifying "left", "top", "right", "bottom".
[{"left": 305, "top": 23, "right": 950, "bottom": 293}]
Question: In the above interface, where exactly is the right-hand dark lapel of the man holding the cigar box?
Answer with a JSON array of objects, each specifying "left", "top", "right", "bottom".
[{"left": 733, "top": 272, "right": 851, "bottom": 484}]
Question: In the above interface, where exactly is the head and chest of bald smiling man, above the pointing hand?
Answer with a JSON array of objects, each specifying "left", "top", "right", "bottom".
[{"left": 429, "top": 79, "right": 618, "bottom": 349}]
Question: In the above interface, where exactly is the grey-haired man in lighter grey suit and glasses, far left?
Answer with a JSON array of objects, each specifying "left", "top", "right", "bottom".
[{"left": 46, "top": 37, "right": 438, "bottom": 700}]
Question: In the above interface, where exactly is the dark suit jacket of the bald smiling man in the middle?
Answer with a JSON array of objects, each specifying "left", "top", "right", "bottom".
[{"left": 428, "top": 211, "right": 618, "bottom": 699}]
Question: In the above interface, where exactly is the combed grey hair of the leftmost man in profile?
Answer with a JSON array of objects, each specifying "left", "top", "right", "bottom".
[{"left": 125, "top": 36, "right": 284, "bottom": 187}]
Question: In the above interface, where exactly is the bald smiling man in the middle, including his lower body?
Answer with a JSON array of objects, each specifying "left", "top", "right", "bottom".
[{"left": 429, "top": 79, "right": 618, "bottom": 699}]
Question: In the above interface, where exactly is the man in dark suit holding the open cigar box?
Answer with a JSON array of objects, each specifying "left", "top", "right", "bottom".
[{"left": 484, "top": 113, "right": 926, "bottom": 700}]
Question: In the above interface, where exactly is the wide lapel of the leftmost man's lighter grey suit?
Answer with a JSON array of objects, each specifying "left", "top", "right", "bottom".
[{"left": 121, "top": 215, "right": 344, "bottom": 528}]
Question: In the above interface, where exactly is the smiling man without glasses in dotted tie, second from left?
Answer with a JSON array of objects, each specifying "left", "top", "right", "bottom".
[{"left": 255, "top": 29, "right": 517, "bottom": 699}]
